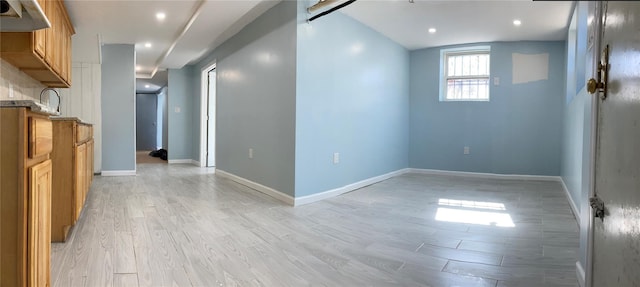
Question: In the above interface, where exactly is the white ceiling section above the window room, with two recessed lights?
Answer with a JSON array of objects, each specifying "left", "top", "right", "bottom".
[{"left": 341, "top": 0, "right": 573, "bottom": 50}]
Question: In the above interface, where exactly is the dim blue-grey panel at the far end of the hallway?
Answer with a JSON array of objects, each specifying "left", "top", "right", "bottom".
[{"left": 136, "top": 94, "right": 158, "bottom": 151}]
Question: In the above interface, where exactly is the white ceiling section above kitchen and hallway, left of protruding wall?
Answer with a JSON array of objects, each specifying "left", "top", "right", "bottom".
[{"left": 65, "top": 0, "right": 279, "bottom": 81}]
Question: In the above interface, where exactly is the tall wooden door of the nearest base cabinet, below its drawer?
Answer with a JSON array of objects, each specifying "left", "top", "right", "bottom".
[{"left": 27, "top": 160, "right": 52, "bottom": 287}]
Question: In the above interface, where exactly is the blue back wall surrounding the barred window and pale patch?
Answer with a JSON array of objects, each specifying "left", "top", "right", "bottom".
[{"left": 409, "top": 41, "right": 565, "bottom": 175}]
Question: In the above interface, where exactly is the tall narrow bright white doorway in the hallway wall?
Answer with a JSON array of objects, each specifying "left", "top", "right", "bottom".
[{"left": 200, "top": 62, "right": 217, "bottom": 167}]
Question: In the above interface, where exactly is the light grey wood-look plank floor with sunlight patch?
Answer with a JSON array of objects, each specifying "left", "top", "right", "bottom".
[{"left": 51, "top": 164, "right": 578, "bottom": 287}]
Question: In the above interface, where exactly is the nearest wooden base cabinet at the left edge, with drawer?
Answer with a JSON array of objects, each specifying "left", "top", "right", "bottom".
[{"left": 0, "top": 107, "right": 53, "bottom": 287}]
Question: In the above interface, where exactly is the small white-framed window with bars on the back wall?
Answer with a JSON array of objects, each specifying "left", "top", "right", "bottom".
[{"left": 440, "top": 46, "right": 491, "bottom": 101}]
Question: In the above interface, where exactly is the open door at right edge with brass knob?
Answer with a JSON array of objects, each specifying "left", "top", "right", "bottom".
[{"left": 591, "top": 1, "right": 640, "bottom": 287}]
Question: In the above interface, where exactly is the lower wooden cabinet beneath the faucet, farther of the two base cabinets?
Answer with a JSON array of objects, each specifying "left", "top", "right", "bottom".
[{"left": 51, "top": 117, "right": 93, "bottom": 242}]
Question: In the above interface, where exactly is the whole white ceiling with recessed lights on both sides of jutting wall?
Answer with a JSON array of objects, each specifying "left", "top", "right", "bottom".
[{"left": 65, "top": 0, "right": 573, "bottom": 92}]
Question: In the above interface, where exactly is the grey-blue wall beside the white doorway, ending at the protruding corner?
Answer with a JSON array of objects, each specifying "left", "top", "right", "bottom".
[{"left": 191, "top": 1, "right": 297, "bottom": 196}]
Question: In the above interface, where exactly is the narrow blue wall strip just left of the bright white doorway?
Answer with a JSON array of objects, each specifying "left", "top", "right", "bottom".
[{"left": 167, "top": 65, "right": 199, "bottom": 160}]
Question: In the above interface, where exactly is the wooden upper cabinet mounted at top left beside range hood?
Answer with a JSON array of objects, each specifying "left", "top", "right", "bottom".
[{"left": 0, "top": 0, "right": 75, "bottom": 88}]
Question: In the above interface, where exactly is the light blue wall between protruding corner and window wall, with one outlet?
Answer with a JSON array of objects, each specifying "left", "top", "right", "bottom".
[{"left": 295, "top": 1, "right": 409, "bottom": 197}]
